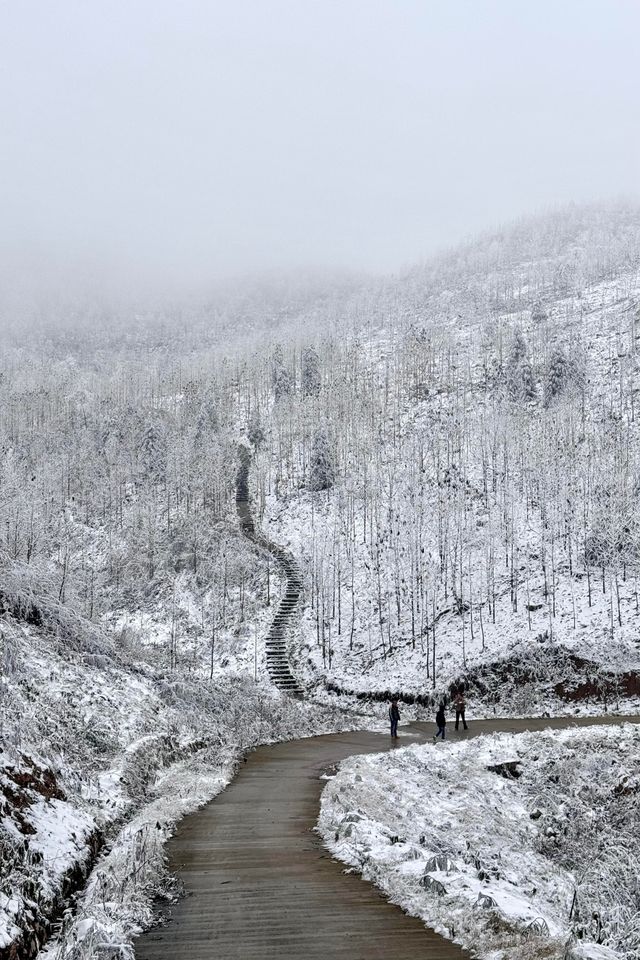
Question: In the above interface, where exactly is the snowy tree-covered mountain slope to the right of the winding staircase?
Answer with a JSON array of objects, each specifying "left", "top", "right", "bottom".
[{"left": 256, "top": 209, "right": 640, "bottom": 708}]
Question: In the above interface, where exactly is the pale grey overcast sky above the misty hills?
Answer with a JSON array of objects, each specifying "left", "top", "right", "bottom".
[{"left": 0, "top": 0, "right": 640, "bottom": 296}]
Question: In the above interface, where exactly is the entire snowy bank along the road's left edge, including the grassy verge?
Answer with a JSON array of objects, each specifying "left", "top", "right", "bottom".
[{"left": 0, "top": 619, "right": 362, "bottom": 960}]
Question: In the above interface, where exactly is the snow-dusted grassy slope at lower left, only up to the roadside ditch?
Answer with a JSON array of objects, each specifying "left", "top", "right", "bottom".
[{"left": 0, "top": 620, "right": 179, "bottom": 950}]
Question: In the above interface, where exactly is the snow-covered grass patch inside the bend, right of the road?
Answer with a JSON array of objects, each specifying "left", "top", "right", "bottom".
[{"left": 319, "top": 724, "right": 640, "bottom": 960}]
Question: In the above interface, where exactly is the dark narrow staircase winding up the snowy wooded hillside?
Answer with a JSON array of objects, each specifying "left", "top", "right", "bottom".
[{"left": 236, "top": 446, "right": 303, "bottom": 696}]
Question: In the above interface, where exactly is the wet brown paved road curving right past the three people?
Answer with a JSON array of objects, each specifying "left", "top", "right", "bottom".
[{"left": 136, "top": 717, "right": 640, "bottom": 960}]
